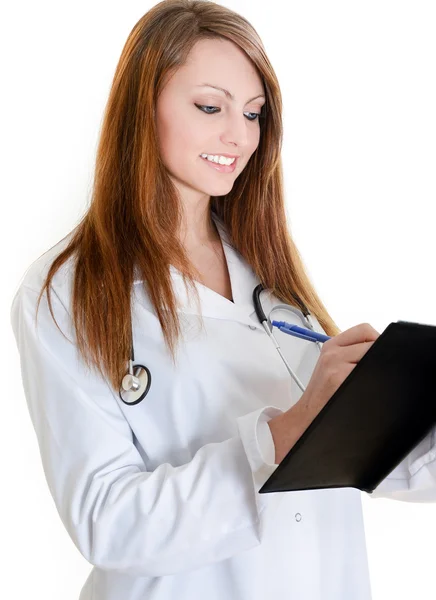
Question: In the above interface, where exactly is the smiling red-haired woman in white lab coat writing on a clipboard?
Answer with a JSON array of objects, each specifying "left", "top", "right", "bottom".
[{"left": 11, "top": 0, "right": 434, "bottom": 600}]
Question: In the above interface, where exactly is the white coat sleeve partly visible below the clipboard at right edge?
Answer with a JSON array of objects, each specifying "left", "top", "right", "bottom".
[{"left": 368, "top": 427, "right": 436, "bottom": 502}]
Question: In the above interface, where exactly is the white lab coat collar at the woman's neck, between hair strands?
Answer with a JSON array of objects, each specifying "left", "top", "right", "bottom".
[{"left": 134, "top": 213, "right": 263, "bottom": 331}]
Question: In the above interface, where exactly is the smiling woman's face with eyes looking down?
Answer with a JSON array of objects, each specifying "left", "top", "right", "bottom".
[{"left": 156, "top": 39, "right": 265, "bottom": 204}]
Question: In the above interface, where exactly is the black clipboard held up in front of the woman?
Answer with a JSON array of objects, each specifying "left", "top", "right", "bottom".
[{"left": 259, "top": 321, "right": 436, "bottom": 494}]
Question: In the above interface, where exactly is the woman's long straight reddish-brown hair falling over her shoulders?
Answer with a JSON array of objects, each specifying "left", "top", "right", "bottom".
[{"left": 38, "top": 0, "right": 340, "bottom": 390}]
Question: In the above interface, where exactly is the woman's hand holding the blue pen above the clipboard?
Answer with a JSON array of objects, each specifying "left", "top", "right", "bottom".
[{"left": 296, "top": 323, "right": 380, "bottom": 420}]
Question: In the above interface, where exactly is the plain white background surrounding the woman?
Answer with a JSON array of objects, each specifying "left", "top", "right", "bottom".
[{"left": 0, "top": 0, "right": 436, "bottom": 600}]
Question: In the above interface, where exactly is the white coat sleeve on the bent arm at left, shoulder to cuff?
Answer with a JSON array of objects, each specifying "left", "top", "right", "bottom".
[{"left": 11, "top": 284, "right": 281, "bottom": 577}]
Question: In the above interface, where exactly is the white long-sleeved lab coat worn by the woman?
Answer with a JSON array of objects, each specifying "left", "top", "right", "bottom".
[{"left": 11, "top": 214, "right": 436, "bottom": 600}]
